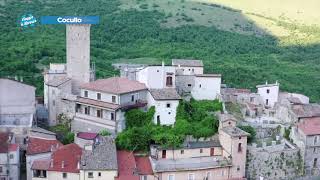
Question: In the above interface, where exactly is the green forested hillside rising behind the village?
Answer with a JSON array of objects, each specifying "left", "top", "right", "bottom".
[{"left": 0, "top": 0, "right": 320, "bottom": 101}]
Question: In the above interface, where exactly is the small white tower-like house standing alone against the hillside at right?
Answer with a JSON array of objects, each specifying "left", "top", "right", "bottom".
[{"left": 257, "top": 82, "right": 279, "bottom": 108}]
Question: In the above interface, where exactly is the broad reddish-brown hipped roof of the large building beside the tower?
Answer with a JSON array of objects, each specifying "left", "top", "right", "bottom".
[{"left": 81, "top": 77, "right": 147, "bottom": 94}]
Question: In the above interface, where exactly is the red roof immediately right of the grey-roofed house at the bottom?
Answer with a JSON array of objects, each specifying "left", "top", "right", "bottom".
[{"left": 116, "top": 151, "right": 139, "bottom": 180}]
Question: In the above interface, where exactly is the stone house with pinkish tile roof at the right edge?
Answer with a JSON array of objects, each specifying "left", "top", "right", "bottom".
[{"left": 290, "top": 117, "right": 320, "bottom": 176}]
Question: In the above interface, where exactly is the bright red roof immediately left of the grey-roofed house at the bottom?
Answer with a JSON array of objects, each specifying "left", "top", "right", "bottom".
[{"left": 48, "top": 143, "right": 82, "bottom": 173}]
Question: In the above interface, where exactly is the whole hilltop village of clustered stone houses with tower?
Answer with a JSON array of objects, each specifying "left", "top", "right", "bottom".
[{"left": 0, "top": 24, "right": 320, "bottom": 180}]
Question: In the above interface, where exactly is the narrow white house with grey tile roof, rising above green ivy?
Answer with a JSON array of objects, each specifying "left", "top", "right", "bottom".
[{"left": 148, "top": 88, "right": 181, "bottom": 125}]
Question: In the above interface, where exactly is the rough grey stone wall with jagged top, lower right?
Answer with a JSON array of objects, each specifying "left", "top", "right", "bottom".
[{"left": 246, "top": 140, "right": 303, "bottom": 180}]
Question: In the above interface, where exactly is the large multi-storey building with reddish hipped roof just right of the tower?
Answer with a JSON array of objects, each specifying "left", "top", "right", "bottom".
[{"left": 72, "top": 77, "right": 147, "bottom": 133}]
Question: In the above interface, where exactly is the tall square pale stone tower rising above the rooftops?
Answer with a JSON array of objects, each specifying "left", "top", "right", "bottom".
[{"left": 66, "top": 24, "right": 94, "bottom": 94}]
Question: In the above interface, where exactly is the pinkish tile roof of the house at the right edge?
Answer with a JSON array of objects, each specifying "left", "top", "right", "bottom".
[{"left": 297, "top": 117, "right": 320, "bottom": 136}]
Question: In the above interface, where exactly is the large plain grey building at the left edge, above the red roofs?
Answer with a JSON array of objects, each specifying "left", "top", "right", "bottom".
[{"left": 0, "top": 78, "right": 36, "bottom": 132}]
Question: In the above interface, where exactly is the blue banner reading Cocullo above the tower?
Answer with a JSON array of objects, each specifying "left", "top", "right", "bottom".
[{"left": 40, "top": 16, "right": 100, "bottom": 24}]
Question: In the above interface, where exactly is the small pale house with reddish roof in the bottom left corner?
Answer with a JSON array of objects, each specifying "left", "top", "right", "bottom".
[{"left": 0, "top": 133, "right": 20, "bottom": 180}]
